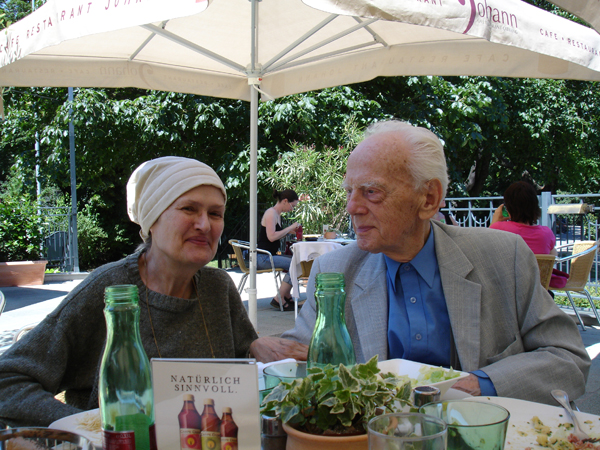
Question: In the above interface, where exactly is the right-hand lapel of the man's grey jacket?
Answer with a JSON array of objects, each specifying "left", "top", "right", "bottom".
[{"left": 433, "top": 224, "right": 481, "bottom": 372}]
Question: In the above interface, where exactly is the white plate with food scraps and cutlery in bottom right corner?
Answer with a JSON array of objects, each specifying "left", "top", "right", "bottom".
[{"left": 467, "top": 397, "right": 600, "bottom": 450}]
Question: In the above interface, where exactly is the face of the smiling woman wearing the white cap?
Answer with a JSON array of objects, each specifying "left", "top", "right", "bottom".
[{"left": 150, "top": 185, "right": 225, "bottom": 266}]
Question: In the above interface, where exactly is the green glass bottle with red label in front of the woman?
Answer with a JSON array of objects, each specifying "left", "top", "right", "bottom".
[{"left": 98, "top": 284, "right": 157, "bottom": 450}]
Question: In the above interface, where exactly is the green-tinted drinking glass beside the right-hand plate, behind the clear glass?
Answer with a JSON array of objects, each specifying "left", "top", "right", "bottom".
[{"left": 419, "top": 400, "right": 510, "bottom": 450}]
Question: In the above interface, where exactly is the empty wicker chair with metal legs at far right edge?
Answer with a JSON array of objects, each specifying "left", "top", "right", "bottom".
[{"left": 551, "top": 241, "right": 600, "bottom": 330}]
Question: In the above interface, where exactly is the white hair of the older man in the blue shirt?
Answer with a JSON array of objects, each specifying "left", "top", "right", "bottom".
[{"left": 364, "top": 120, "right": 448, "bottom": 198}]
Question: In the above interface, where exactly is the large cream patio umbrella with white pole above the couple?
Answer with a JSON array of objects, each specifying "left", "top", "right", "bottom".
[{"left": 0, "top": 0, "right": 600, "bottom": 324}]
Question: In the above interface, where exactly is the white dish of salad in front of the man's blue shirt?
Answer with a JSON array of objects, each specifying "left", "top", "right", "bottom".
[{"left": 377, "top": 358, "right": 469, "bottom": 399}]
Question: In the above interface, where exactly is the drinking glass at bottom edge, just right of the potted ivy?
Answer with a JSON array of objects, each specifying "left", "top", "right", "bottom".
[{"left": 367, "top": 413, "right": 447, "bottom": 450}]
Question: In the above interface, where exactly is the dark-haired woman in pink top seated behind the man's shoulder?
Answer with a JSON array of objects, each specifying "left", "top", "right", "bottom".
[{"left": 490, "top": 181, "right": 557, "bottom": 255}]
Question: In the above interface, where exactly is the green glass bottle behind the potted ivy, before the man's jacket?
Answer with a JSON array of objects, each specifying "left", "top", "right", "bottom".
[{"left": 307, "top": 272, "right": 356, "bottom": 367}]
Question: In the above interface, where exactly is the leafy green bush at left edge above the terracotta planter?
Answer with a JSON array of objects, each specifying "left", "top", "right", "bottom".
[{"left": 0, "top": 194, "right": 42, "bottom": 261}]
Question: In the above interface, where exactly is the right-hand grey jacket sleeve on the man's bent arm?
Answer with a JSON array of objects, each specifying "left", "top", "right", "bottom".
[{"left": 480, "top": 239, "right": 591, "bottom": 404}]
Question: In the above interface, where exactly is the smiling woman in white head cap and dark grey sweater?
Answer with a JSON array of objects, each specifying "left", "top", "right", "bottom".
[{"left": 0, "top": 156, "right": 257, "bottom": 426}]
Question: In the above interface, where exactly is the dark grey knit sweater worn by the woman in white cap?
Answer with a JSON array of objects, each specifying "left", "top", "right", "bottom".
[{"left": 0, "top": 253, "right": 257, "bottom": 427}]
